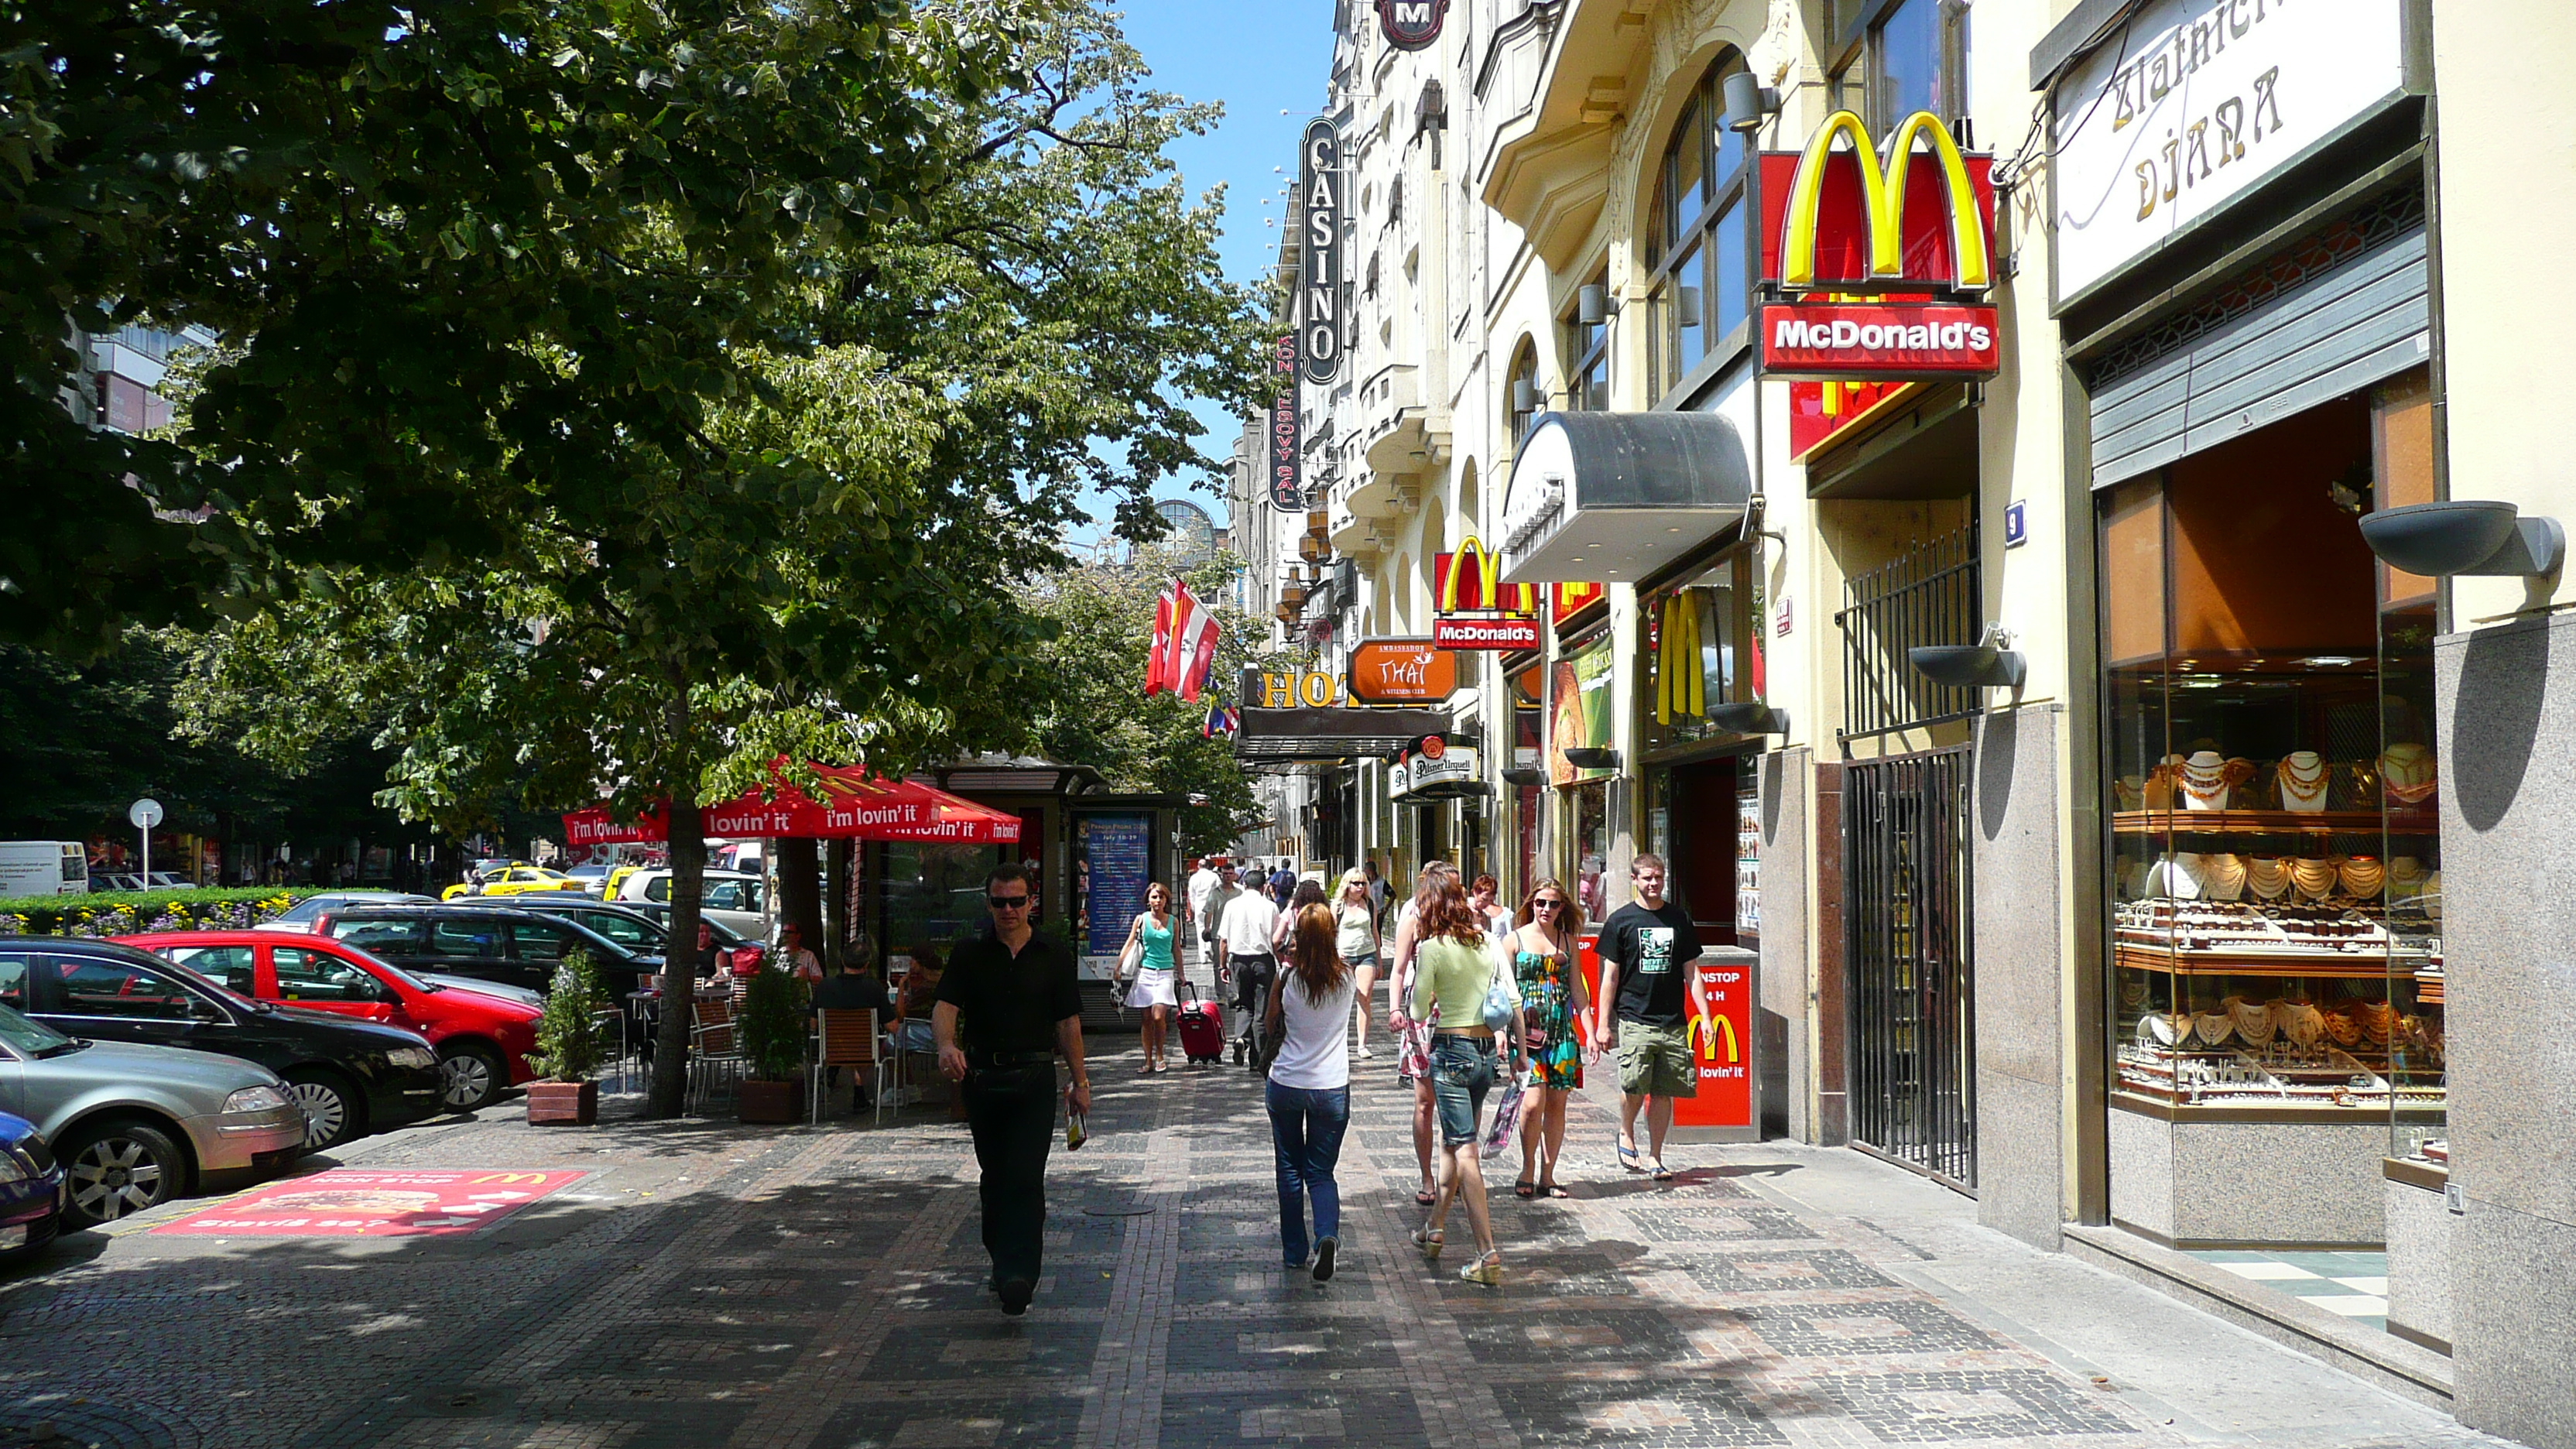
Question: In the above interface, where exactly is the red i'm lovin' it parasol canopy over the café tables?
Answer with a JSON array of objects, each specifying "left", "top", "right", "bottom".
[{"left": 564, "top": 766, "right": 1020, "bottom": 846}]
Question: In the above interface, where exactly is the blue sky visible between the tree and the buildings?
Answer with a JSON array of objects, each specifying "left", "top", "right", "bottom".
[{"left": 1061, "top": 0, "right": 1332, "bottom": 549}]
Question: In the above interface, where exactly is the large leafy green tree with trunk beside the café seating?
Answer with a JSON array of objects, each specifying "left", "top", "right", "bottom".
[{"left": 166, "top": 2, "right": 1259, "bottom": 1112}]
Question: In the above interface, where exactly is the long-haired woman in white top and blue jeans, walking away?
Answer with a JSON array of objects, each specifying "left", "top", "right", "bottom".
[{"left": 1265, "top": 903, "right": 1355, "bottom": 1284}]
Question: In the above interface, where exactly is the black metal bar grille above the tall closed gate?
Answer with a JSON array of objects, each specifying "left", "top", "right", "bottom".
[{"left": 1834, "top": 523, "right": 1984, "bottom": 742}]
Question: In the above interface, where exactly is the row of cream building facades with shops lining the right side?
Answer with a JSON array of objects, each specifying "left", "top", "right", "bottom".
[{"left": 1234, "top": 0, "right": 2576, "bottom": 1447}]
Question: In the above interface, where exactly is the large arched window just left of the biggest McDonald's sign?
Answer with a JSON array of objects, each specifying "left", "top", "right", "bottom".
[{"left": 1646, "top": 52, "right": 1754, "bottom": 397}]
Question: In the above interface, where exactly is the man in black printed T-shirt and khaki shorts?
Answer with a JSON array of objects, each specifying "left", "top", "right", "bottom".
[{"left": 1592, "top": 856, "right": 1708, "bottom": 1184}]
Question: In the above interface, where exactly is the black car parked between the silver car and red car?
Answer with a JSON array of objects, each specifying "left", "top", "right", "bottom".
[{"left": 0, "top": 936, "right": 446, "bottom": 1153}]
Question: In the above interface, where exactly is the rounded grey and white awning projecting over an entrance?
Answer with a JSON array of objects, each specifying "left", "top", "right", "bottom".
[{"left": 1502, "top": 413, "right": 1752, "bottom": 583}]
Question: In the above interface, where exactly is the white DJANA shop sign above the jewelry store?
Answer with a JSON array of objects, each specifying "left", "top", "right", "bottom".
[{"left": 2050, "top": 0, "right": 2409, "bottom": 307}]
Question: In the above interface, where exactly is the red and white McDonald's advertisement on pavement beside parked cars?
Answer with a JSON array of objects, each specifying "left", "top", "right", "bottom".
[{"left": 152, "top": 1168, "right": 584, "bottom": 1238}]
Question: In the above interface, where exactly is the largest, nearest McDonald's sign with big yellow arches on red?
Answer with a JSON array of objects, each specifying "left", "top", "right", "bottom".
[{"left": 1759, "top": 111, "right": 2002, "bottom": 384}]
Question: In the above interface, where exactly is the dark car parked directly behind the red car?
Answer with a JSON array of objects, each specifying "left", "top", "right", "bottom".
[{"left": 312, "top": 903, "right": 662, "bottom": 998}]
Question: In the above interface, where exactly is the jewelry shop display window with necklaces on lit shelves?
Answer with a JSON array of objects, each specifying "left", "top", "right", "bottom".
[{"left": 2099, "top": 389, "right": 2442, "bottom": 1245}]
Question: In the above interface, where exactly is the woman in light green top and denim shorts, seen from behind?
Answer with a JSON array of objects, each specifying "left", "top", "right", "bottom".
[{"left": 1406, "top": 874, "right": 1528, "bottom": 1286}]
